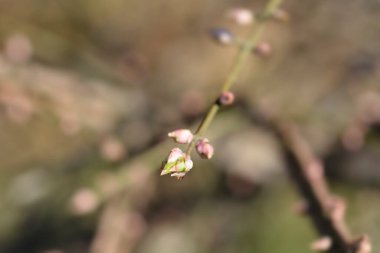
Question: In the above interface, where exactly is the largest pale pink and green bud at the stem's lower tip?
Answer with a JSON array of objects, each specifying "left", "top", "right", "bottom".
[{"left": 161, "top": 148, "right": 193, "bottom": 179}]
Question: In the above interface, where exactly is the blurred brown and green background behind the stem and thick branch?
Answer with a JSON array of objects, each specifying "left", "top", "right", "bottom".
[{"left": 0, "top": 0, "right": 380, "bottom": 253}]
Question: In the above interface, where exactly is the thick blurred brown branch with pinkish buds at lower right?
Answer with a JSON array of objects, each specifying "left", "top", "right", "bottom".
[{"left": 243, "top": 103, "right": 370, "bottom": 253}]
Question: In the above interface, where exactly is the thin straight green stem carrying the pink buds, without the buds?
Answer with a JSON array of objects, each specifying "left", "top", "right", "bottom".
[{"left": 186, "top": 0, "right": 282, "bottom": 155}]
